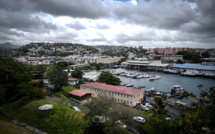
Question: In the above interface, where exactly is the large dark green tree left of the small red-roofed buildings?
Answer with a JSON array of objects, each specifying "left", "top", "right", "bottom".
[{"left": 46, "top": 66, "right": 68, "bottom": 89}]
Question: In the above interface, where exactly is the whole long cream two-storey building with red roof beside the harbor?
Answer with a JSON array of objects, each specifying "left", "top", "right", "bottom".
[{"left": 80, "top": 82, "right": 144, "bottom": 106}]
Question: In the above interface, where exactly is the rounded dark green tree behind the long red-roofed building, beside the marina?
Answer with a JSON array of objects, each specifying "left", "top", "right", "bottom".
[{"left": 97, "top": 71, "right": 121, "bottom": 85}]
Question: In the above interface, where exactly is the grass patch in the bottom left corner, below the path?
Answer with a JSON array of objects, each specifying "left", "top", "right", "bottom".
[{"left": 0, "top": 120, "right": 33, "bottom": 134}]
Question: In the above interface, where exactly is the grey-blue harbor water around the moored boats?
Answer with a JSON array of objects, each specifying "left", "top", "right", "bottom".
[{"left": 85, "top": 68, "right": 215, "bottom": 103}]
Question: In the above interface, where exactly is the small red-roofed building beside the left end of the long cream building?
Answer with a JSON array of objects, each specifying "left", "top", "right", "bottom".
[{"left": 69, "top": 90, "right": 92, "bottom": 105}]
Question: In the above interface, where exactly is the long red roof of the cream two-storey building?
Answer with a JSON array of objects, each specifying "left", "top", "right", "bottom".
[{"left": 81, "top": 82, "right": 142, "bottom": 95}]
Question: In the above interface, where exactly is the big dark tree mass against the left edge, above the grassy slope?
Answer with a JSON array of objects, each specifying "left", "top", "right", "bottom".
[{"left": 0, "top": 57, "right": 32, "bottom": 101}]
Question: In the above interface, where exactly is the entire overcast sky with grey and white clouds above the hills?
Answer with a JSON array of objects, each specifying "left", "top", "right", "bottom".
[{"left": 0, "top": 0, "right": 215, "bottom": 48}]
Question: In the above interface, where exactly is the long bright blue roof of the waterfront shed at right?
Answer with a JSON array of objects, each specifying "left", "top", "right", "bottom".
[{"left": 173, "top": 64, "right": 215, "bottom": 71}]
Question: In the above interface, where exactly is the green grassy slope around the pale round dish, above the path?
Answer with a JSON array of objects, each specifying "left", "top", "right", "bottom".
[{"left": 2, "top": 99, "right": 84, "bottom": 132}]
